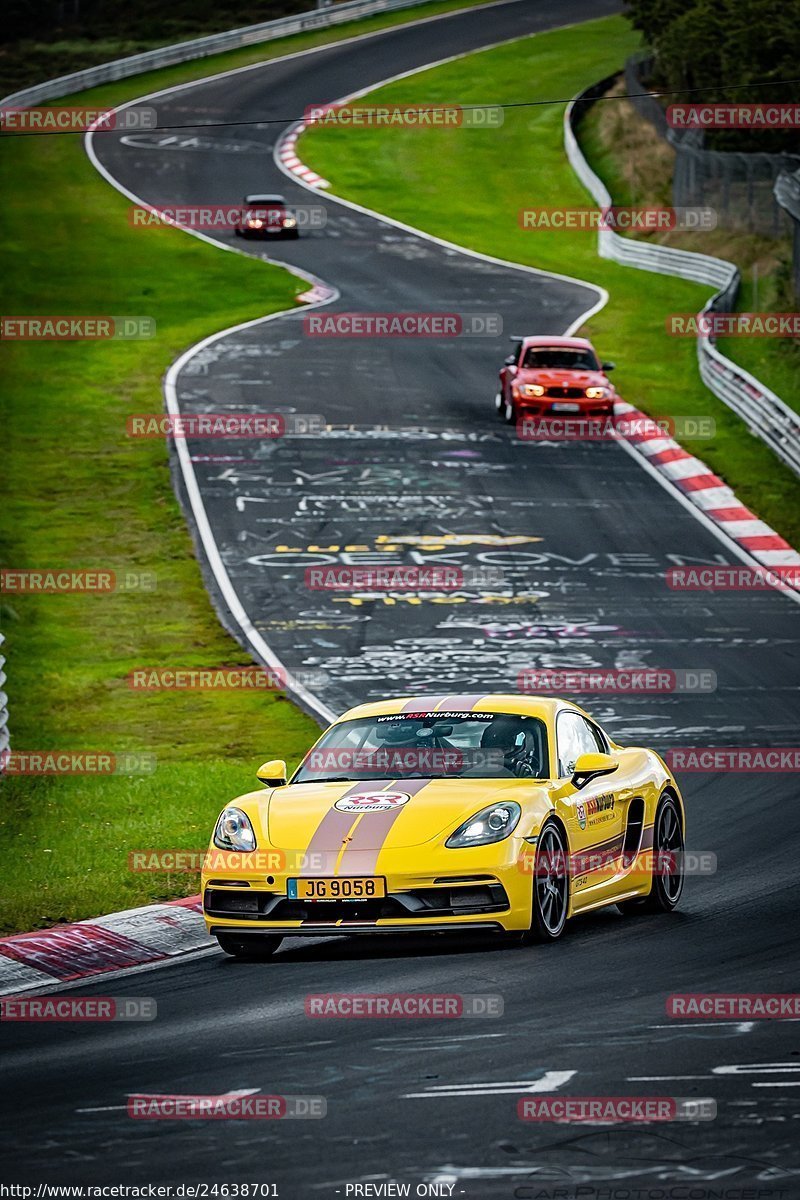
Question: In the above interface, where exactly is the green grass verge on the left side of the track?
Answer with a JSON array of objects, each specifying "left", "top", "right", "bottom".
[{"left": 0, "top": 0, "right": 503, "bottom": 934}]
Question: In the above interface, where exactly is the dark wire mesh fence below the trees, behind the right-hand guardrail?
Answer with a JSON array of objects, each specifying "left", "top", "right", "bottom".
[{"left": 625, "top": 58, "right": 800, "bottom": 238}]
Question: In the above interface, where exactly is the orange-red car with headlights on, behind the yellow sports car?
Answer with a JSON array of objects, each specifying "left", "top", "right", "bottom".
[{"left": 494, "top": 337, "right": 619, "bottom": 425}]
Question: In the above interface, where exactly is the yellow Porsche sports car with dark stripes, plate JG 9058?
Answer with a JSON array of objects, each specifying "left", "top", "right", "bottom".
[{"left": 203, "top": 695, "right": 685, "bottom": 958}]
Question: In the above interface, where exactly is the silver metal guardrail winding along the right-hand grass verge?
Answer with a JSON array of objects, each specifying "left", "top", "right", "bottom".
[{"left": 564, "top": 76, "right": 800, "bottom": 475}]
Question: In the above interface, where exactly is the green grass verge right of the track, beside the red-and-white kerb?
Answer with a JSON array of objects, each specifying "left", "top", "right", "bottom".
[{"left": 300, "top": 8, "right": 800, "bottom": 545}]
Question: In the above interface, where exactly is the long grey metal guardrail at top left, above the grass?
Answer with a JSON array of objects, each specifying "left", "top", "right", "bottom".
[{"left": 0, "top": 0, "right": 441, "bottom": 106}]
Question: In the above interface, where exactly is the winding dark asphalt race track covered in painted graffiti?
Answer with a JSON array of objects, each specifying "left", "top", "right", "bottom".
[{"left": 0, "top": 0, "right": 800, "bottom": 1200}]
